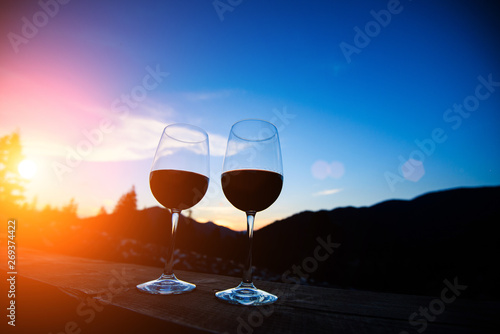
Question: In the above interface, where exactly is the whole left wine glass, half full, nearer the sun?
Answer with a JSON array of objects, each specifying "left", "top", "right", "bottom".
[{"left": 137, "top": 124, "right": 210, "bottom": 295}]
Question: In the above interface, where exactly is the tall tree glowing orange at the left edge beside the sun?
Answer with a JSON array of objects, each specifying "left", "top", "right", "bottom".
[{"left": 0, "top": 132, "right": 24, "bottom": 206}]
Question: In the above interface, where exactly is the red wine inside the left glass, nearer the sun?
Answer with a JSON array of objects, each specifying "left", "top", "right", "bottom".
[{"left": 149, "top": 169, "right": 208, "bottom": 210}]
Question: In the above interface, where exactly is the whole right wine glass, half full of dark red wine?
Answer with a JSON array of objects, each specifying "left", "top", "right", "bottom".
[{"left": 215, "top": 119, "right": 283, "bottom": 305}]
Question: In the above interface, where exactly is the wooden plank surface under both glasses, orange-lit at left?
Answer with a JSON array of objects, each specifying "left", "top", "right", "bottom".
[{"left": 0, "top": 247, "right": 500, "bottom": 334}]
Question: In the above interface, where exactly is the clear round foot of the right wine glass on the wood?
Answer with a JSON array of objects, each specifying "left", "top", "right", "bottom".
[{"left": 215, "top": 282, "right": 278, "bottom": 306}]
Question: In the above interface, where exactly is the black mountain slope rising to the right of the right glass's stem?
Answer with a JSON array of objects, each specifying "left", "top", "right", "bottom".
[{"left": 254, "top": 187, "right": 500, "bottom": 298}]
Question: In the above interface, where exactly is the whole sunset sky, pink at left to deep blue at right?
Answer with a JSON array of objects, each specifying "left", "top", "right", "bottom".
[{"left": 0, "top": 0, "right": 500, "bottom": 230}]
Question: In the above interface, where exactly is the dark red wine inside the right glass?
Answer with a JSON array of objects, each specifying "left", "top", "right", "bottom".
[{"left": 222, "top": 169, "right": 283, "bottom": 212}]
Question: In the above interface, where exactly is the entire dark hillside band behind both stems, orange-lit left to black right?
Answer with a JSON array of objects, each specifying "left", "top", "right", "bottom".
[{"left": 7, "top": 186, "right": 500, "bottom": 299}]
